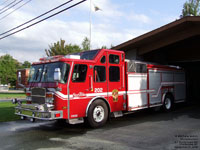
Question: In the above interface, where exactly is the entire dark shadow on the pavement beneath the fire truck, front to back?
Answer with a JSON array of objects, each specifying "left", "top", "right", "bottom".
[{"left": 28, "top": 103, "right": 200, "bottom": 132}]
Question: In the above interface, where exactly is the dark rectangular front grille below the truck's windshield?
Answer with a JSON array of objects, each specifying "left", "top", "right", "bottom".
[{"left": 31, "top": 88, "right": 46, "bottom": 104}]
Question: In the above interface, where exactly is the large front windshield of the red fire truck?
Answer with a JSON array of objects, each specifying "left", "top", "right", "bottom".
[{"left": 29, "top": 62, "right": 70, "bottom": 83}]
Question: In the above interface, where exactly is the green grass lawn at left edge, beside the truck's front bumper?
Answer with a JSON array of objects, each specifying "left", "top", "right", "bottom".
[{"left": 0, "top": 101, "right": 20, "bottom": 122}]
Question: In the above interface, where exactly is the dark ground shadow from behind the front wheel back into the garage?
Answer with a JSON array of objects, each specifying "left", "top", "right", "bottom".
[{"left": 105, "top": 103, "right": 200, "bottom": 129}]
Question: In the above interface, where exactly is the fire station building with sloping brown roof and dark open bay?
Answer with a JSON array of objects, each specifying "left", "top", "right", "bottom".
[{"left": 113, "top": 16, "right": 200, "bottom": 101}]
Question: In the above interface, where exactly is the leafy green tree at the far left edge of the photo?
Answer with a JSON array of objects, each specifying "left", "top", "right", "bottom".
[{"left": 0, "top": 54, "right": 20, "bottom": 86}]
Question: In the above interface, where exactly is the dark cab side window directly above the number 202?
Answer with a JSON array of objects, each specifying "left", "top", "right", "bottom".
[{"left": 94, "top": 66, "right": 106, "bottom": 82}]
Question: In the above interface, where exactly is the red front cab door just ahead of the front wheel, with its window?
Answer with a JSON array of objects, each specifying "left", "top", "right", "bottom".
[{"left": 69, "top": 62, "right": 90, "bottom": 119}]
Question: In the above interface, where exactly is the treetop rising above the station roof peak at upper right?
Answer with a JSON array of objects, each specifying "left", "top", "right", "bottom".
[{"left": 181, "top": 0, "right": 200, "bottom": 17}]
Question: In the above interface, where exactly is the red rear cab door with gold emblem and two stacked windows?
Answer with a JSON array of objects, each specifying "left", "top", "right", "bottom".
[{"left": 107, "top": 52, "right": 125, "bottom": 112}]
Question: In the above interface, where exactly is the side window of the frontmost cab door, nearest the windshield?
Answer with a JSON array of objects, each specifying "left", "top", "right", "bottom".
[{"left": 72, "top": 64, "right": 87, "bottom": 82}]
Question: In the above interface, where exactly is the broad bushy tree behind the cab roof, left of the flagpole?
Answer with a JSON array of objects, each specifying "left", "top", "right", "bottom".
[{"left": 45, "top": 39, "right": 81, "bottom": 56}]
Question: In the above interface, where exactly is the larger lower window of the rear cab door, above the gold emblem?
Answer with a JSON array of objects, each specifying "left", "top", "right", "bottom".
[{"left": 109, "top": 66, "right": 120, "bottom": 82}]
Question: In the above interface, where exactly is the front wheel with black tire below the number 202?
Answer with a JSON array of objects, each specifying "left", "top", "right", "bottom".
[{"left": 87, "top": 99, "right": 108, "bottom": 128}]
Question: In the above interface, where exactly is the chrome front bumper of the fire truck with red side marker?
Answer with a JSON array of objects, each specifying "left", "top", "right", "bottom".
[{"left": 15, "top": 104, "right": 63, "bottom": 120}]
